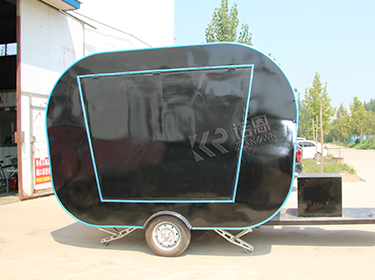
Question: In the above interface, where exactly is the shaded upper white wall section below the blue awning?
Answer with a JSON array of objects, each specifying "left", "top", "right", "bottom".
[{"left": 20, "top": 0, "right": 83, "bottom": 95}]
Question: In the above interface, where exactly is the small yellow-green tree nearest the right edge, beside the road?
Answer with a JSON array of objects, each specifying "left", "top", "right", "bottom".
[{"left": 350, "top": 97, "right": 371, "bottom": 144}]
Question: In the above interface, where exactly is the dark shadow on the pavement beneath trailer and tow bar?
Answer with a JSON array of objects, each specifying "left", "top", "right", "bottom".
[{"left": 51, "top": 222, "right": 375, "bottom": 257}]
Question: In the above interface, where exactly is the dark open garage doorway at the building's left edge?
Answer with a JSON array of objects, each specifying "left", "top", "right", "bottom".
[{"left": 0, "top": 0, "right": 18, "bottom": 194}]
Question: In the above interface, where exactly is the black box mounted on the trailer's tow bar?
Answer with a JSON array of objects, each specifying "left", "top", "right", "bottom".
[{"left": 298, "top": 173, "right": 342, "bottom": 217}]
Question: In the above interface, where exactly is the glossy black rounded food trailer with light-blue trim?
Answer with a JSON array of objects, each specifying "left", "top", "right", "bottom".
[{"left": 46, "top": 43, "right": 375, "bottom": 256}]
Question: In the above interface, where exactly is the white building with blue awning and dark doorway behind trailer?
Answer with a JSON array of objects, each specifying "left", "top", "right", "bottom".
[{"left": 0, "top": 0, "right": 174, "bottom": 199}]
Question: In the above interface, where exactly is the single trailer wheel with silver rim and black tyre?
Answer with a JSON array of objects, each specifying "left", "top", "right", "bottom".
[{"left": 145, "top": 216, "right": 190, "bottom": 257}]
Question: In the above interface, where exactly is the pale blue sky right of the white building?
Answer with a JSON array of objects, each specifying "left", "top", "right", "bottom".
[{"left": 175, "top": 0, "right": 375, "bottom": 110}]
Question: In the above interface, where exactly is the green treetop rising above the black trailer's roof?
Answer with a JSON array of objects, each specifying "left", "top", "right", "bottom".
[{"left": 205, "top": 0, "right": 253, "bottom": 46}]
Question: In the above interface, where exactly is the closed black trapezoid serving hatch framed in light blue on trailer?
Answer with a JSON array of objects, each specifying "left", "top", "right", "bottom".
[{"left": 81, "top": 69, "right": 251, "bottom": 200}]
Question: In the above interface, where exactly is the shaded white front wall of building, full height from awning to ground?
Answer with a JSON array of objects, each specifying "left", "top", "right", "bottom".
[{"left": 18, "top": 0, "right": 84, "bottom": 197}]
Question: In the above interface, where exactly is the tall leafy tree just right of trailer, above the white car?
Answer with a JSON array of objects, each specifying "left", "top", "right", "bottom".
[{"left": 303, "top": 72, "right": 336, "bottom": 135}]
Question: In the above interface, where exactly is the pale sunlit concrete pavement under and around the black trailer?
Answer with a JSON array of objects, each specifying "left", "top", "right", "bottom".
[{"left": 0, "top": 178, "right": 375, "bottom": 279}]
